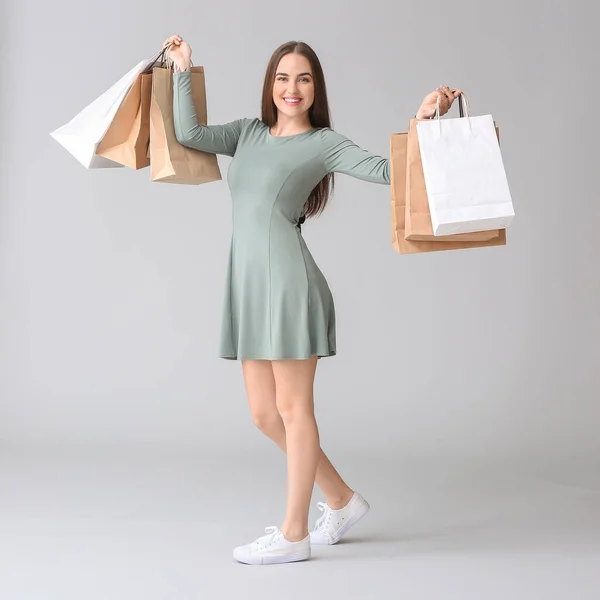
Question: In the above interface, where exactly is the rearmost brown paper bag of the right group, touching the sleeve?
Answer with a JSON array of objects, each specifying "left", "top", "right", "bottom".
[{"left": 390, "top": 133, "right": 506, "bottom": 254}]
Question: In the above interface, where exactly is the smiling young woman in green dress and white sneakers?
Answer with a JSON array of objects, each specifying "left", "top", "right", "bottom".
[{"left": 164, "top": 35, "right": 461, "bottom": 564}]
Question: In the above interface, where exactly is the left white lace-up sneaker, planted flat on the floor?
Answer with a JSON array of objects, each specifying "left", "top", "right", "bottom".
[{"left": 233, "top": 526, "right": 310, "bottom": 565}]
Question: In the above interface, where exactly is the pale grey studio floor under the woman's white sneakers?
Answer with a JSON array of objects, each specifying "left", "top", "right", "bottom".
[{"left": 0, "top": 447, "right": 600, "bottom": 600}]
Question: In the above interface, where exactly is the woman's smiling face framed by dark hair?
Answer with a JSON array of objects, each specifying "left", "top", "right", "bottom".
[{"left": 273, "top": 53, "right": 315, "bottom": 118}]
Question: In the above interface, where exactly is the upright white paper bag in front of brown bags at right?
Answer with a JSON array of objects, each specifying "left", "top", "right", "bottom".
[{"left": 417, "top": 95, "right": 515, "bottom": 236}]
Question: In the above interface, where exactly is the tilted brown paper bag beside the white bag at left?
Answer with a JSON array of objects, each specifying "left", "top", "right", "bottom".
[{"left": 96, "top": 73, "right": 152, "bottom": 170}]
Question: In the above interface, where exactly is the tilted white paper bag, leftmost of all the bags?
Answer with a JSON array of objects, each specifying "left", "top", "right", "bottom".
[{"left": 50, "top": 59, "right": 148, "bottom": 169}]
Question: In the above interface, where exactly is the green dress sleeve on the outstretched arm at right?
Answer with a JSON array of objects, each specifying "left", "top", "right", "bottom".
[{"left": 323, "top": 129, "right": 390, "bottom": 185}]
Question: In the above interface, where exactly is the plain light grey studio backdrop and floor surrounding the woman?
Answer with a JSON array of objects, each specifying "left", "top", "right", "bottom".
[{"left": 0, "top": 0, "right": 600, "bottom": 600}]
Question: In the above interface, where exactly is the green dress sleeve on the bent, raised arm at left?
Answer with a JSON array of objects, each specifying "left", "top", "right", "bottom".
[{"left": 173, "top": 71, "right": 244, "bottom": 156}]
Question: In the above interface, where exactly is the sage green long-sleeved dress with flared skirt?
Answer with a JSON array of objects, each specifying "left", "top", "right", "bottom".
[{"left": 173, "top": 71, "right": 390, "bottom": 360}]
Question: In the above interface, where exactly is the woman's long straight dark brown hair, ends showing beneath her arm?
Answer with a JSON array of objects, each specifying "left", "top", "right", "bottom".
[{"left": 262, "top": 41, "right": 335, "bottom": 217}]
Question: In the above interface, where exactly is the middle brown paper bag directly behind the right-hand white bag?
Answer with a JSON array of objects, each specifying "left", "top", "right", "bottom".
[{"left": 405, "top": 119, "right": 500, "bottom": 242}]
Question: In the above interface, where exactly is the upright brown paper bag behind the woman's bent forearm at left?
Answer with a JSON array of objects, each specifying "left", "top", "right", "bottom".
[{"left": 149, "top": 67, "right": 221, "bottom": 185}]
